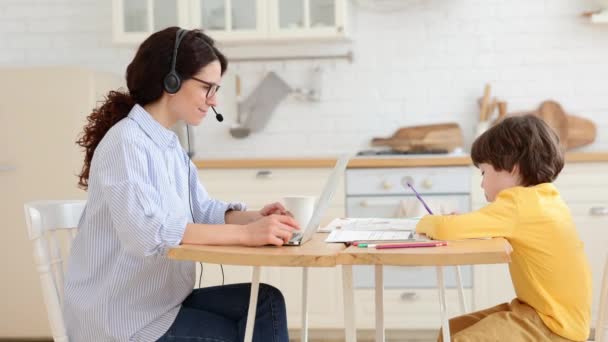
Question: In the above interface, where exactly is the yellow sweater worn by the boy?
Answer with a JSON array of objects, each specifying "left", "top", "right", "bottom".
[{"left": 416, "top": 183, "right": 592, "bottom": 341}]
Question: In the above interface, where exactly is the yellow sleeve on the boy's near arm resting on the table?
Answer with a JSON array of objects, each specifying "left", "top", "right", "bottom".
[{"left": 416, "top": 190, "right": 517, "bottom": 240}]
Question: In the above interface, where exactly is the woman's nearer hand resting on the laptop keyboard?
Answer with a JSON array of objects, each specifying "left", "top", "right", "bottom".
[{"left": 242, "top": 214, "right": 300, "bottom": 246}]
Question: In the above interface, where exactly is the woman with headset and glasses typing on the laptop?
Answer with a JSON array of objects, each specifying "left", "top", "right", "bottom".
[{"left": 64, "top": 27, "right": 298, "bottom": 341}]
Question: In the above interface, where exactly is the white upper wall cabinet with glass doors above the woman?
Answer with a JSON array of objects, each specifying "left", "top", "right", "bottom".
[{"left": 113, "top": 0, "right": 347, "bottom": 44}]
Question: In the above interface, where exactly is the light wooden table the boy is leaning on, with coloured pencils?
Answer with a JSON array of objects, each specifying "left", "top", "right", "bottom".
[{"left": 337, "top": 238, "right": 512, "bottom": 342}]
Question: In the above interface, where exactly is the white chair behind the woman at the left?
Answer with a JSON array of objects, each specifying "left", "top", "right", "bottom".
[{"left": 24, "top": 200, "right": 86, "bottom": 342}]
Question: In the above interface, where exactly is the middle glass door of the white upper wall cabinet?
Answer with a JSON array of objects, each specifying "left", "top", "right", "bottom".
[{"left": 190, "top": 0, "right": 267, "bottom": 42}]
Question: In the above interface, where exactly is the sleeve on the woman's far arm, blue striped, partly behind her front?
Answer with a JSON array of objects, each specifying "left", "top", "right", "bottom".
[{"left": 186, "top": 155, "right": 247, "bottom": 224}]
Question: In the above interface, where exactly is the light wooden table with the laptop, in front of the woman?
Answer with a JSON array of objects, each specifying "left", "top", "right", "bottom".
[{"left": 169, "top": 233, "right": 346, "bottom": 342}]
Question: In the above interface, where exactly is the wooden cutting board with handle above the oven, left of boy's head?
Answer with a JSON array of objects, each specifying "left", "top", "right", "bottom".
[{"left": 372, "top": 123, "right": 463, "bottom": 152}]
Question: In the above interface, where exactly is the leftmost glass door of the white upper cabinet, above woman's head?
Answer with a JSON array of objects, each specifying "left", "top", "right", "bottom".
[{"left": 112, "top": 0, "right": 188, "bottom": 44}]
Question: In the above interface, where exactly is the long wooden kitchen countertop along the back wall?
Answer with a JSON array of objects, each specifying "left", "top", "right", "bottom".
[{"left": 194, "top": 152, "right": 608, "bottom": 169}]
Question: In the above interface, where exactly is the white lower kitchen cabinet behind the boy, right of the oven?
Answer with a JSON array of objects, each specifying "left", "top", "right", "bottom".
[{"left": 471, "top": 162, "right": 608, "bottom": 325}]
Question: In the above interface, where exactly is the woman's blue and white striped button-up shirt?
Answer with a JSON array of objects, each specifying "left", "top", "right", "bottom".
[{"left": 63, "top": 105, "right": 244, "bottom": 341}]
